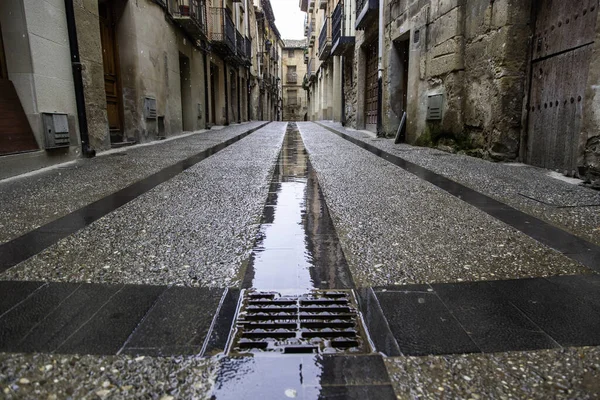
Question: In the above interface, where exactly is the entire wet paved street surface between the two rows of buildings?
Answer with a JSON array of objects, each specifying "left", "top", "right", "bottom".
[{"left": 0, "top": 121, "right": 600, "bottom": 400}]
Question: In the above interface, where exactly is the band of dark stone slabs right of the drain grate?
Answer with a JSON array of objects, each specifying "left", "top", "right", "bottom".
[{"left": 374, "top": 275, "right": 600, "bottom": 356}]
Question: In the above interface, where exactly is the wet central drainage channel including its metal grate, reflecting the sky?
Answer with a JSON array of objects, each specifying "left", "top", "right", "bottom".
[{"left": 212, "top": 123, "right": 395, "bottom": 399}]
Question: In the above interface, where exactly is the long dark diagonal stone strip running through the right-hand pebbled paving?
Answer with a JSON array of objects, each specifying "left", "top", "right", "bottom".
[{"left": 317, "top": 123, "right": 600, "bottom": 272}]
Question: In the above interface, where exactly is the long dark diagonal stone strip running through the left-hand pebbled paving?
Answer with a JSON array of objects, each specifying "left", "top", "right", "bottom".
[{"left": 0, "top": 124, "right": 267, "bottom": 272}]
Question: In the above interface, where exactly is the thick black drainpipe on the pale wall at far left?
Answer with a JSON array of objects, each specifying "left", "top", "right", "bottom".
[{"left": 65, "top": 0, "right": 96, "bottom": 158}]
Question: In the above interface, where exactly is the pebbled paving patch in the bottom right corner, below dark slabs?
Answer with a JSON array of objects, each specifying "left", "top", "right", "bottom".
[{"left": 384, "top": 347, "right": 600, "bottom": 400}]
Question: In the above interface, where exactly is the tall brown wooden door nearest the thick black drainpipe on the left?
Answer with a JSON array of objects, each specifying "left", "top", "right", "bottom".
[{"left": 98, "top": 1, "right": 123, "bottom": 143}]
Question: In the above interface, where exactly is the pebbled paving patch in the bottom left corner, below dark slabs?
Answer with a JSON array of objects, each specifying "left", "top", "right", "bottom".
[{"left": 0, "top": 353, "right": 218, "bottom": 400}]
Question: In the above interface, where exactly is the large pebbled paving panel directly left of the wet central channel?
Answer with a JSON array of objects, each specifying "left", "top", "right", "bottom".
[{"left": 0, "top": 123, "right": 286, "bottom": 287}]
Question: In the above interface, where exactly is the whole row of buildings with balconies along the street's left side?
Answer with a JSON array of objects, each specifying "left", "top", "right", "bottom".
[{"left": 0, "top": 0, "right": 281, "bottom": 179}]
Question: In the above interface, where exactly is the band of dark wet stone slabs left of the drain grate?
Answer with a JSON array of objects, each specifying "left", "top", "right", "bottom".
[{"left": 0, "top": 281, "right": 224, "bottom": 356}]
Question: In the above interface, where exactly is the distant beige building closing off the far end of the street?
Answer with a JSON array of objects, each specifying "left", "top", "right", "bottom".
[{"left": 282, "top": 40, "right": 307, "bottom": 121}]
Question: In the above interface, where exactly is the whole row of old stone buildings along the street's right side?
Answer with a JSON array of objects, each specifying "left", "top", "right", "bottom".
[{"left": 300, "top": 0, "right": 600, "bottom": 186}]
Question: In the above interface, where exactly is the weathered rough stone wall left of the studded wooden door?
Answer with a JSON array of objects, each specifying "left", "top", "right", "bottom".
[{"left": 383, "top": 0, "right": 531, "bottom": 159}]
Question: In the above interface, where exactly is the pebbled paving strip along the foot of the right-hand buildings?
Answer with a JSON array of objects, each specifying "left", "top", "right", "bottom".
[{"left": 321, "top": 121, "right": 600, "bottom": 245}]
